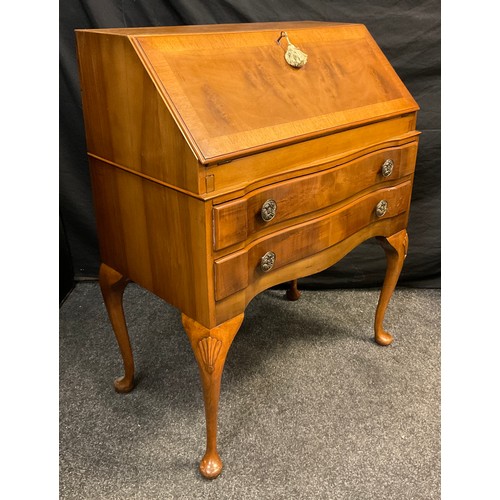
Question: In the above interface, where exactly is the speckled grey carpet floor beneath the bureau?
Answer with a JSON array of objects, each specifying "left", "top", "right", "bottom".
[{"left": 60, "top": 282, "right": 440, "bottom": 500}]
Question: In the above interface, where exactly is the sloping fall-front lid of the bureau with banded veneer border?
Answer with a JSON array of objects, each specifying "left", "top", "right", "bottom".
[{"left": 131, "top": 24, "right": 417, "bottom": 163}]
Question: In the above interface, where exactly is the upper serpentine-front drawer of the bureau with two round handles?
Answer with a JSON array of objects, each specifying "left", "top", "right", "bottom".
[{"left": 213, "top": 142, "right": 417, "bottom": 250}]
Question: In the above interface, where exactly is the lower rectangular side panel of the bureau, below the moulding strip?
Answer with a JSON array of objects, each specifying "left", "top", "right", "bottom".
[{"left": 90, "top": 158, "right": 214, "bottom": 327}]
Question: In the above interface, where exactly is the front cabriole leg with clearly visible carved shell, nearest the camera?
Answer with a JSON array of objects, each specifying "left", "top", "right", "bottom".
[{"left": 182, "top": 313, "right": 243, "bottom": 479}]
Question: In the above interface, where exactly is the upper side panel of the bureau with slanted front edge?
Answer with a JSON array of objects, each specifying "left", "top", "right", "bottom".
[{"left": 76, "top": 31, "right": 201, "bottom": 193}]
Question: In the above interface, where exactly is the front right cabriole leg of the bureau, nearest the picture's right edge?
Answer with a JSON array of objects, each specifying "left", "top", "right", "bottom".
[{"left": 375, "top": 229, "right": 408, "bottom": 345}]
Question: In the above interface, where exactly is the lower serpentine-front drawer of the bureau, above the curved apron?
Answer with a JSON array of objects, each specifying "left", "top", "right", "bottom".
[{"left": 215, "top": 181, "right": 412, "bottom": 300}]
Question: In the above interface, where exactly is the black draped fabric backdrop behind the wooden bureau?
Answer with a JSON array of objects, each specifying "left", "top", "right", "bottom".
[{"left": 59, "top": 0, "right": 441, "bottom": 288}]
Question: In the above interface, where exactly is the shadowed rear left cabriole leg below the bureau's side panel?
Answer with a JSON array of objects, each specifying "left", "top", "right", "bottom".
[{"left": 99, "top": 264, "right": 134, "bottom": 392}]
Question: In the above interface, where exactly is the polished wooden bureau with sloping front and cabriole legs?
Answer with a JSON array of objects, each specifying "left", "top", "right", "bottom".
[{"left": 76, "top": 22, "right": 418, "bottom": 478}]
